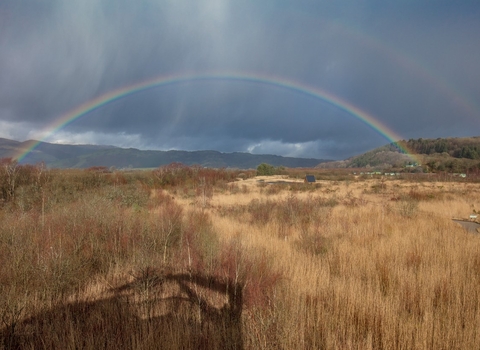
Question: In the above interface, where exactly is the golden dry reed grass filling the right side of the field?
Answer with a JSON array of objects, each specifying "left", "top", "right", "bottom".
[{"left": 213, "top": 176, "right": 480, "bottom": 349}]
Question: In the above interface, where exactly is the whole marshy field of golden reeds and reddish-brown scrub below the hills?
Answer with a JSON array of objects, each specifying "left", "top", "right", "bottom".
[{"left": 0, "top": 162, "right": 480, "bottom": 349}]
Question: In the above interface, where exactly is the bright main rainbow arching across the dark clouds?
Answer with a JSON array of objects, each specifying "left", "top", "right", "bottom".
[{"left": 14, "top": 73, "right": 419, "bottom": 163}]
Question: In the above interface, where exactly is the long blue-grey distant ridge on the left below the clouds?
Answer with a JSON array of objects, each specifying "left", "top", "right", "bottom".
[{"left": 0, "top": 138, "right": 328, "bottom": 169}]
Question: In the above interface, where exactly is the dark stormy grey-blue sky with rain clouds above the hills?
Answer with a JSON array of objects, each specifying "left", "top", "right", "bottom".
[{"left": 0, "top": 0, "right": 480, "bottom": 159}]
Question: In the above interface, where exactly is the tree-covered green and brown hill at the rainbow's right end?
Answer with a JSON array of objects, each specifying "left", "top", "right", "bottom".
[{"left": 318, "top": 137, "right": 480, "bottom": 172}]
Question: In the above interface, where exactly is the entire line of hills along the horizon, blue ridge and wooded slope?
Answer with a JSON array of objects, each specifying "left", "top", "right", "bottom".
[{"left": 0, "top": 136, "right": 480, "bottom": 172}]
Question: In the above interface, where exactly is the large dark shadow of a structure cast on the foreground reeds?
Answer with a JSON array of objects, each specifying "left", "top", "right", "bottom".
[{"left": 0, "top": 269, "right": 243, "bottom": 349}]
